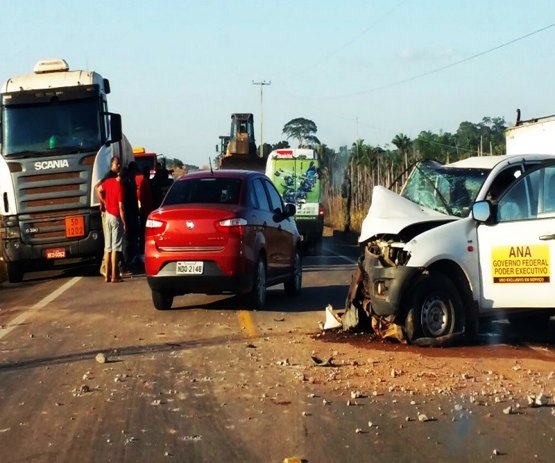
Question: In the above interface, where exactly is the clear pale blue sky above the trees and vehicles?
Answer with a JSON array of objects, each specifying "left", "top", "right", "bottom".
[{"left": 0, "top": 0, "right": 555, "bottom": 166}]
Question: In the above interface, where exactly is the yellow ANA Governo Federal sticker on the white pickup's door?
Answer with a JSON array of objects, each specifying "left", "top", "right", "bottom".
[{"left": 491, "top": 244, "right": 551, "bottom": 283}]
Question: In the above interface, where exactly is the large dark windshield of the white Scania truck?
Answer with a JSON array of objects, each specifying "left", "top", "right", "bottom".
[{"left": 2, "top": 98, "right": 102, "bottom": 157}]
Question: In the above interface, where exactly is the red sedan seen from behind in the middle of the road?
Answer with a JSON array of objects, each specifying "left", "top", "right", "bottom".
[{"left": 145, "top": 170, "right": 302, "bottom": 310}]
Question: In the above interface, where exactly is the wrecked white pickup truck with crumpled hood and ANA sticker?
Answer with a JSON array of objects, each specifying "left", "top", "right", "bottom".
[{"left": 343, "top": 155, "right": 555, "bottom": 345}]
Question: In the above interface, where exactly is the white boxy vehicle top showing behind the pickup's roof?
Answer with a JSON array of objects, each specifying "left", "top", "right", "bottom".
[{"left": 505, "top": 111, "right": 555, "bottom": 154}]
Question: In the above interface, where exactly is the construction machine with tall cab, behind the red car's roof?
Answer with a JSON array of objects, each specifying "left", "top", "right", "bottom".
[{"left": 219, "top": 113, "right": 266, "bottom": 172}]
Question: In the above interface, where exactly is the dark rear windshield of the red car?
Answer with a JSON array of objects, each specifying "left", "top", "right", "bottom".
[{"left": 163, "top": 177, "right": 241, "bottom": 206}]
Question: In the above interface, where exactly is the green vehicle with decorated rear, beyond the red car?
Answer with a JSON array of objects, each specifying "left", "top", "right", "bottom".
[{"left": 266, "top": 148, "right": 324, "bottom": 252}]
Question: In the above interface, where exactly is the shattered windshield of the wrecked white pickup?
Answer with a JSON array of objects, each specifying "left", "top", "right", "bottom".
[{"left": 401, "top": 161, "right": 488, "bottom": 217}]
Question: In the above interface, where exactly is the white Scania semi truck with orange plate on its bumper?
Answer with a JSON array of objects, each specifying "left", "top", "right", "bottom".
[{"left": 0, "top": 59, "right": 133, "bottom": 282}]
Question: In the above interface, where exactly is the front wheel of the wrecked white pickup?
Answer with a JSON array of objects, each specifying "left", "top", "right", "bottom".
[{"left": 405, "top": 272, "right": 464, "bottom": 342}]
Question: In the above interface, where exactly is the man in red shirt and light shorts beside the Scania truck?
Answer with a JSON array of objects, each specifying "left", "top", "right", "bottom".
[{"left": 96, "top": 168, "right": 127, "bottom": 283}]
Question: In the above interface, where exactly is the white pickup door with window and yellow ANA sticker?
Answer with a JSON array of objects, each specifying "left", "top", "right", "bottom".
[{"left": 477, "top": 162, "right": 555, "bottom": 310}]
